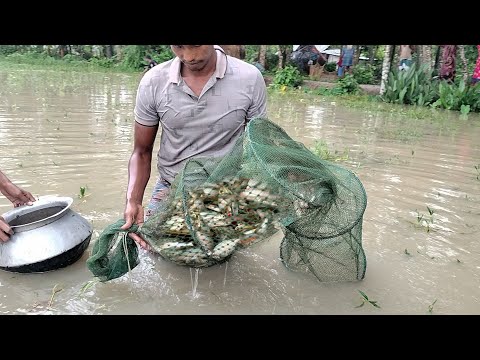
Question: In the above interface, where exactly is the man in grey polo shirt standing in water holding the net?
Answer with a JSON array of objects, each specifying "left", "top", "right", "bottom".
[{"left": 122, "top": 45, "right": 266, "bottom": 249}]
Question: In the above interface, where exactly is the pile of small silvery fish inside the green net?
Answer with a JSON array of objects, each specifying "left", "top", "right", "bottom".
[{"left": 142, "top": 178, "right": 278, "bottom": 267}]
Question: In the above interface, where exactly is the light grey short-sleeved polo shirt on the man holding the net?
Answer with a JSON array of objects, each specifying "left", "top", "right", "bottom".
[{"left": 134, "top": 46, "right": 266, "bottom": 182}]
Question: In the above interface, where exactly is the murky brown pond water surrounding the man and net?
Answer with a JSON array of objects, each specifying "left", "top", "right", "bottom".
[{"left": 0, "top": 70, "right": 480, "bottom": 314}]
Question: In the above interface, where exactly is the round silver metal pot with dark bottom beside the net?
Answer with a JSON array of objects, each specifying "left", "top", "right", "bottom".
[{"left": 0, "top": 196, "right": 93, "bottom": 273}]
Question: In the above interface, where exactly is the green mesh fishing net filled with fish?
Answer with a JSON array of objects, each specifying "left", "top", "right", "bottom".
[{"left": 87, "top": 118, "right": 367, "bottom": 281}]
